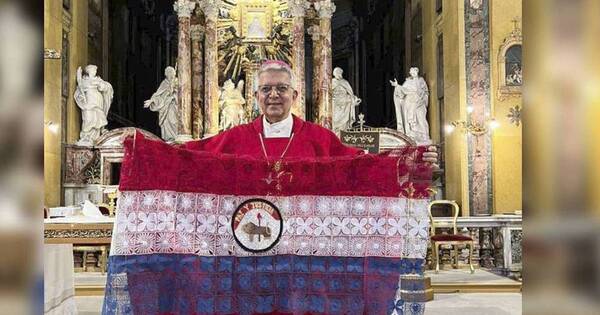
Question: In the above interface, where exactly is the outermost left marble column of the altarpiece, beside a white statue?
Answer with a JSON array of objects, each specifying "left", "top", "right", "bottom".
[{"left": 173, "top": 0, "right": 196, "bottom": 142}]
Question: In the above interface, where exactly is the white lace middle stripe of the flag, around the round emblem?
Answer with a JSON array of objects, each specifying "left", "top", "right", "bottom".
[{"left": 111, "top": 190, "right": 429, "bottom": 258}]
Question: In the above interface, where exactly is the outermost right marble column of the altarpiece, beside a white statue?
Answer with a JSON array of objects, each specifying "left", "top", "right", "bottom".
[{"left": 315, "top": 0, "right": 335, "bottom": 129}]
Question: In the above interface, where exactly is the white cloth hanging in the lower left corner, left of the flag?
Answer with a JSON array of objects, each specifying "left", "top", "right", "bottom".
[{"left": 44, "top": 244, "right": 77, "bottom": 315}]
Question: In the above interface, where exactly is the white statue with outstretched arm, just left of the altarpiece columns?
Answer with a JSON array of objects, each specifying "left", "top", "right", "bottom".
[{"left": 144, "top": 66, "right": 178, "bottom": 141}]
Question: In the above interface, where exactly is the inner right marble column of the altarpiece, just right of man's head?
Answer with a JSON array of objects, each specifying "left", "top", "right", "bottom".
[{"left": 288, "top": 0, "right": 310, "bottom": 119}]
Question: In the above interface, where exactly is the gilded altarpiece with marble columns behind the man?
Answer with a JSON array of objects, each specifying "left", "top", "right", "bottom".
[{"left": 173, "top": 0, "right": 336, "bottom": 141}]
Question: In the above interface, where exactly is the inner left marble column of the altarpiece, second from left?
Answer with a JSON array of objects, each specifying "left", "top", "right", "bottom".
[{"left": 198, "top": 0, "right": 221, "bottom": 136}]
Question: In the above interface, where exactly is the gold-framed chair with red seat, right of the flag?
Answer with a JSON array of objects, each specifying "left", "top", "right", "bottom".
[{"left": 429, "top": 200, "right": 475, "bottom": 273}]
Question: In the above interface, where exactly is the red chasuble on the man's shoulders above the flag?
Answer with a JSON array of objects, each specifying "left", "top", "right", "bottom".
[{"left": 184, "top": 116, "right": 363, "bottom": 158}]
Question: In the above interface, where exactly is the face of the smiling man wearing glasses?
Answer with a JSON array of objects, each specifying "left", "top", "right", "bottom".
[{"left": 254, "top": 71, "right": 298, "bottom": 123}]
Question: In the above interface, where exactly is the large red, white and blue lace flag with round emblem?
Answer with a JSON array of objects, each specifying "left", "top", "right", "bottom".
[{"left": 103, "top": 133, "right": 431, "bottom": 314}]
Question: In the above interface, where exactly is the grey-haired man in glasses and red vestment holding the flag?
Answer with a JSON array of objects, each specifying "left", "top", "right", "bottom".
[{"left": 184, "top": 61, "right": 437, "bottom": 164}]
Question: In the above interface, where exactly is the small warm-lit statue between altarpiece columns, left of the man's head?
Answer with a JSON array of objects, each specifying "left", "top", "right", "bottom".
[{"left": 219, "top": 79, "right": 246, "bottom": 131}]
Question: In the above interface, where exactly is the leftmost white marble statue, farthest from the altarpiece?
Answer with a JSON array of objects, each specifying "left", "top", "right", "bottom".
[{"left": 74, "top": 65, "right": 114, "bottom": 146}]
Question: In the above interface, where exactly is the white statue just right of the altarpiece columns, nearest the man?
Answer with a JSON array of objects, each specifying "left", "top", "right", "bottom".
[{"left": 331, "top": 67, "right": 361, "bottom": 134}]
